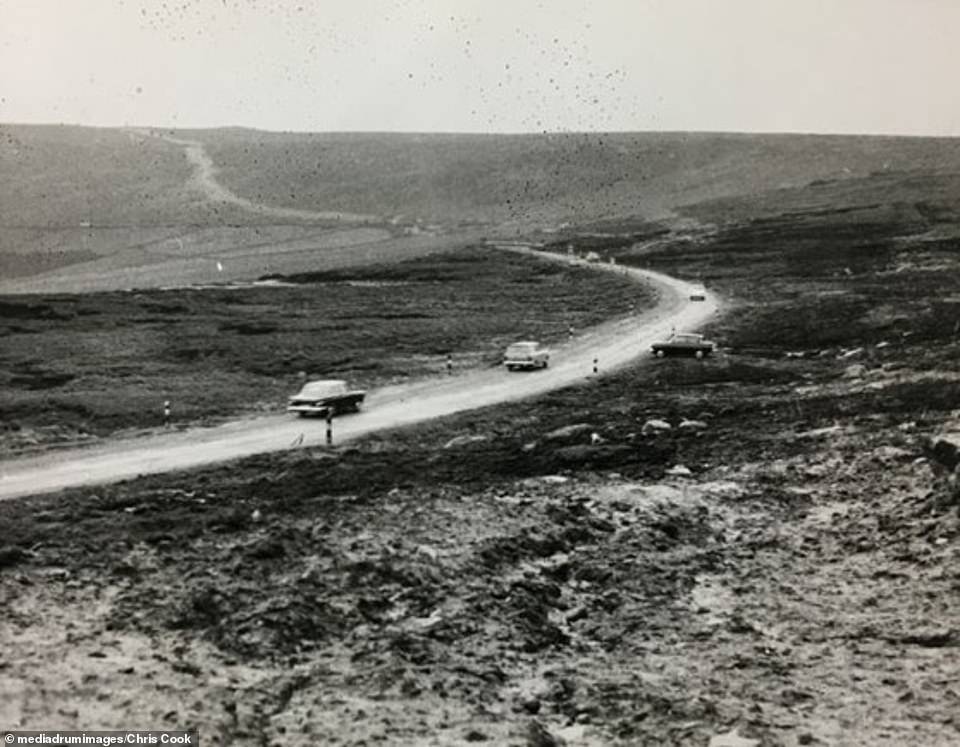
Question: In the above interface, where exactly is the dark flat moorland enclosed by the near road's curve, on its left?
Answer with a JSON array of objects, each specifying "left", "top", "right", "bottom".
[{"left": 0, "top": 247, "right": 652, "bottom": 451}]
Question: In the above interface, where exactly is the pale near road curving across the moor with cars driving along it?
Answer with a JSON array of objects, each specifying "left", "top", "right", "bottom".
[{"left": 0, "top": 254, "right": 719, "bottom": 499}]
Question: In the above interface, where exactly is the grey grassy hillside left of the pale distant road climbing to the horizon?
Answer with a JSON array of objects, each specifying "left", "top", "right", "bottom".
[{"left": 0, "top": 125, "right": 284, "bottom": 290}]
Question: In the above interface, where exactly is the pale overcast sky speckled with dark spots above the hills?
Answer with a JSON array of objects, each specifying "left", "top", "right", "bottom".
[{"left": 0, "top": 0, "right": 960, "bottom": 135}]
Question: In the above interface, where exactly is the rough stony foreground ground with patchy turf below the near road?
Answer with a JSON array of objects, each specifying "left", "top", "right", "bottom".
[{"left": 0, "top": 356, "right": 960, "bottom": 747}]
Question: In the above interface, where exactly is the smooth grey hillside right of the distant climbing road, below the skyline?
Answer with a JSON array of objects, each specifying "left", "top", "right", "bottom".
[{"left": 193, "top": 130, "right": 960, "bottom": 227}]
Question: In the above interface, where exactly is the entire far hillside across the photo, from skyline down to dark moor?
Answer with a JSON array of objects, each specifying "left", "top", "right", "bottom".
[{"left": 0, "top": 125, "right": 960, "bottom": 293}]
